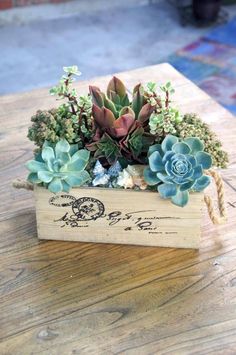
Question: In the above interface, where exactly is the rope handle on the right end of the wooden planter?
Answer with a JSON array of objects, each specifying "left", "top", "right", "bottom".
[{"left": 204, "top": 170, "right": 227, "bottom": 224}]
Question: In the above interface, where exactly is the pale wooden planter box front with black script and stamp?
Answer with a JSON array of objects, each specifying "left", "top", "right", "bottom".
[{"left": 35, "top": 187, "right": 203, "bottom": 248}]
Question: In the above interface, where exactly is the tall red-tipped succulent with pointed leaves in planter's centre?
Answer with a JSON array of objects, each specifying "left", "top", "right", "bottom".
[{"left": 87, "top": 77, "right": 154, "bottom": 164}]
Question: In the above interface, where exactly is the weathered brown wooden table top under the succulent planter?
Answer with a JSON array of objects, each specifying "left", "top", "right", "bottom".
[{"left": 0, "top": 64, "right": 236, "bottom": 355}]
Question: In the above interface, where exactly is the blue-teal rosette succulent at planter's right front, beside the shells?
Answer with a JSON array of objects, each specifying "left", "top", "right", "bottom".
[{"left": 144, "top": 135, "right": 212, "bottom": 207}]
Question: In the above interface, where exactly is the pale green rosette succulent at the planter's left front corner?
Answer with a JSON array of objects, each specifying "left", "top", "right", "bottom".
[{"left": 26, "top": 139, "right": 90, "bottom": 193}]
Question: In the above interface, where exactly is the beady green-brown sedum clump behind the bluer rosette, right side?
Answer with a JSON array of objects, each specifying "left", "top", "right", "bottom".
[{"left": 176, "top": 113, "right": 229, "bottom": 168}]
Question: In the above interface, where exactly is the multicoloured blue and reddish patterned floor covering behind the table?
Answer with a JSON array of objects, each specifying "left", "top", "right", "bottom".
[{"left": 168, "top": 17, "right": 236, "bottom": 114}]
